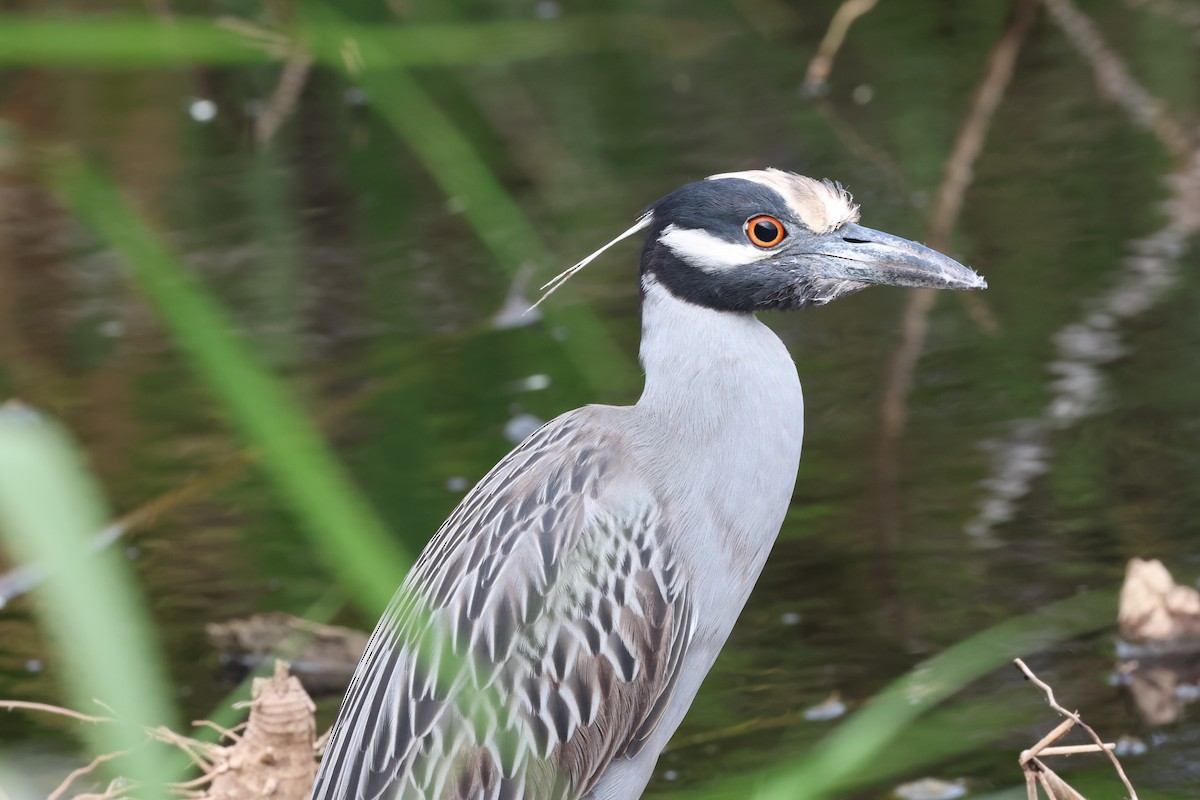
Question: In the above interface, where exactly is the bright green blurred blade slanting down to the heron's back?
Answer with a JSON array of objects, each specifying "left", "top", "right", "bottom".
[{"left": 49, "top": 156, "right": 410, "bottom": 609}]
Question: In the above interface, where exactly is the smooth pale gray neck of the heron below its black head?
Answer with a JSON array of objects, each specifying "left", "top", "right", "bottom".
[{"left": 631, "top": 276, "right": 804, "bottom": 593}]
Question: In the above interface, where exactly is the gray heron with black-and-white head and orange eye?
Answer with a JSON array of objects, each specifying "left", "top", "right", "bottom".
[{"left": 313, "top": 169, "right": 986, "bottom": 800}]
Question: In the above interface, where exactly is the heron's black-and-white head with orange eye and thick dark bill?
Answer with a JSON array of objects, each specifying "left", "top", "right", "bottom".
[{"left": 635, "top": 169, "right": 988, "bottom": 312}]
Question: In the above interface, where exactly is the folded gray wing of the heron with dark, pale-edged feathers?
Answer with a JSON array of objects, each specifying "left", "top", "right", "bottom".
[{"left": 312, "top": 409, "right": 695, "bottom": 800}]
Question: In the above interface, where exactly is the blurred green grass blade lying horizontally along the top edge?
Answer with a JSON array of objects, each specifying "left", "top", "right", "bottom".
[{"left": 0, "top": 14, "right": 715, "bottom": 70}]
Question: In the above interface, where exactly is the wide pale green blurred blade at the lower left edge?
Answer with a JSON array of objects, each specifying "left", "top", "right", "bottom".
[{"left": 0, "top": 407, "right": 175, "bottom": 796}]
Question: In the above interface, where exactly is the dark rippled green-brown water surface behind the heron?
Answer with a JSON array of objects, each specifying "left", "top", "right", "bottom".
[{"left": 0, "top": 0, "right": 1200, "bottom": 796}]
